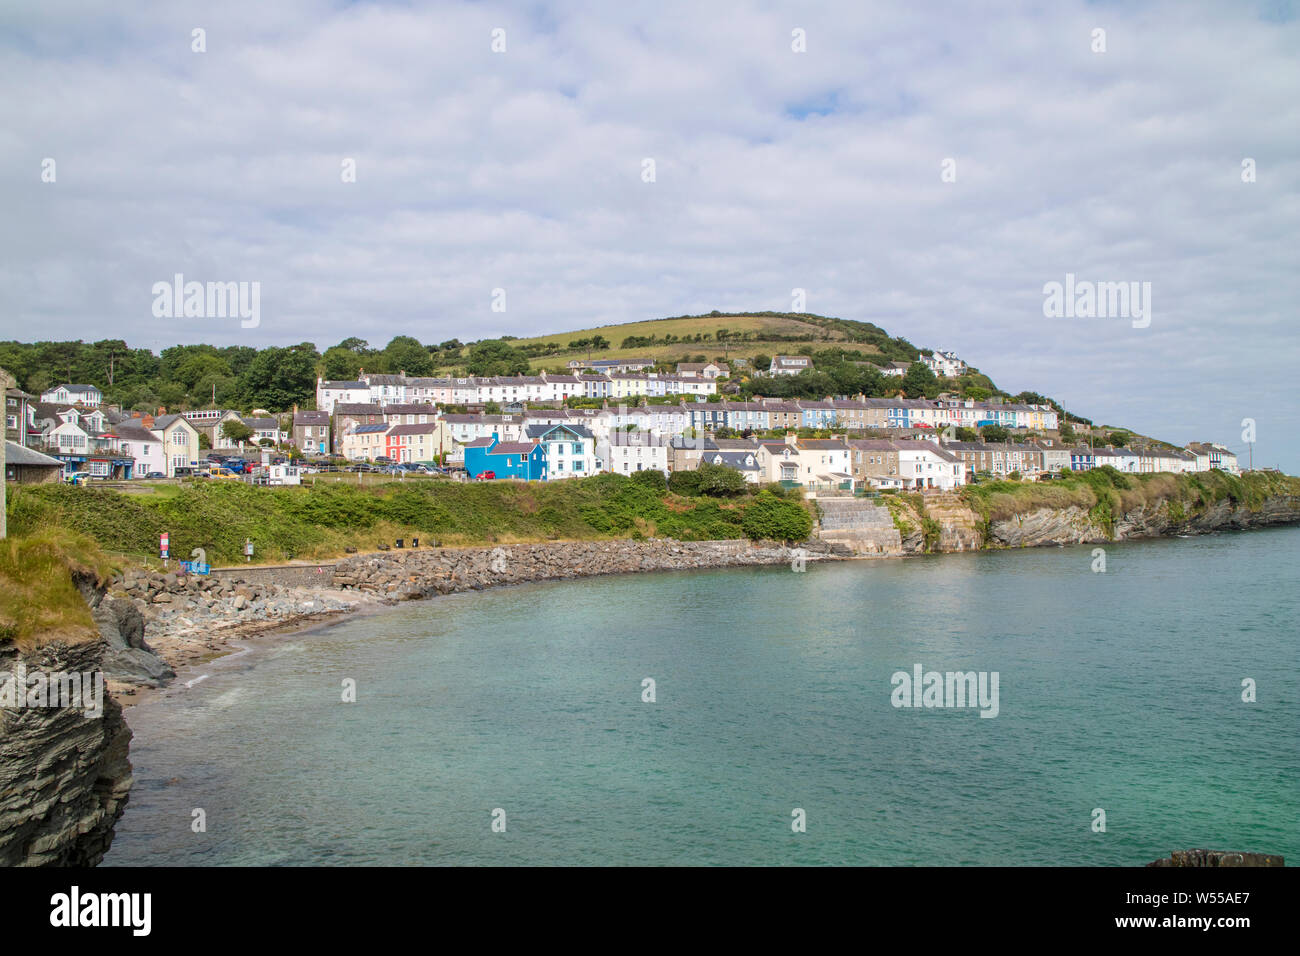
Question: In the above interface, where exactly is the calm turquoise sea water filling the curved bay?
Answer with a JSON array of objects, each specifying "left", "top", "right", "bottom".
[{"left": 105, "top": 528, "right": 1300, "bottom": 865}]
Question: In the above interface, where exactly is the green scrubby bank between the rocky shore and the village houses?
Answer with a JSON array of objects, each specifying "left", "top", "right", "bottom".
[{"left": 9, "top": 472, "right": 811, "bottom": 564}]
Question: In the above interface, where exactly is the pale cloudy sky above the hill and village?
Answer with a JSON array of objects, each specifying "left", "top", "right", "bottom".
[{"left": 0, "top": 0, "right": 1300, "bottom": 473}]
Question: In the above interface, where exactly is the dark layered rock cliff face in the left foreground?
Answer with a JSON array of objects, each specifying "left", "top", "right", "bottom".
[{"left": 0, "top": 640, "right": 131, "bottom": 866}]
